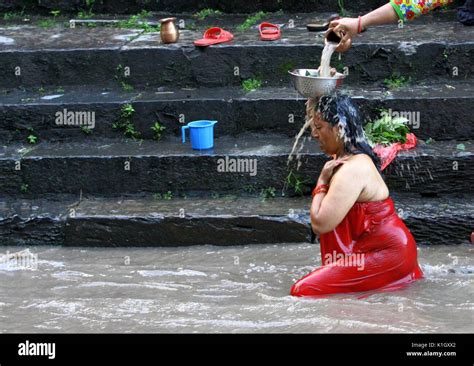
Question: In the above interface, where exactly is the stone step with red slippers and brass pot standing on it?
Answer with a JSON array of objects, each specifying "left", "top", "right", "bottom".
[{"left": 0, "top": 17, "right": 474, "bottom": 88}]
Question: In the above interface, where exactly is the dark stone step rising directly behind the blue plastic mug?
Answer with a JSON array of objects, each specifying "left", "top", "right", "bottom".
[{"left": 0, "top": 82, "right": 474, "bottom": 143}]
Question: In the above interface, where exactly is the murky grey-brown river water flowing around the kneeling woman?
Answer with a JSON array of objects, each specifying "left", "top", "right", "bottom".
[{"left": 0, "top": 244, "right": 474, "bottom": 333}]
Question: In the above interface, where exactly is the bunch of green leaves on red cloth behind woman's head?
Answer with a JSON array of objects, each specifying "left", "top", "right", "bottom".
[{"left": 364, "top": 110, "right": 410, "bottom": 147}]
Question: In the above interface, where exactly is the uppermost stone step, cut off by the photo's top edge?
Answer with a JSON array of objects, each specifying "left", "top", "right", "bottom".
[{"left": 0, "top": 0, "right": 462, "bottom": 14}]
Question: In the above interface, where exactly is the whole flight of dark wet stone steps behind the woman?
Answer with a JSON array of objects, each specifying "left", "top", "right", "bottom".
[{"left": 0, "top": 1, "right": 474, "bottom": 246}]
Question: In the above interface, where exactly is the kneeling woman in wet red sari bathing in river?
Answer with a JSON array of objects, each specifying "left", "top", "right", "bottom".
[{"left": 291, "top": 96, "right": 423, "bottom": 296}]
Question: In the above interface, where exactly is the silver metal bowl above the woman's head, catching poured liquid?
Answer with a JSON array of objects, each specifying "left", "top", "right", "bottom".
[{"left": 288, "top": 69, "right": 345, "bottom": 98}]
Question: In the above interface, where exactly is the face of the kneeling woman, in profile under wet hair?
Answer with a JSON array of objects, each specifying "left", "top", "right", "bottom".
[{"left": 308, "top": 109, "right": 344, "bottom": 155}]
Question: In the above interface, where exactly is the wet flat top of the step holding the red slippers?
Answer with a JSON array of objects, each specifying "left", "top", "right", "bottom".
[{"left": 0, "top": 15, "right": 474, "bottom": 53}]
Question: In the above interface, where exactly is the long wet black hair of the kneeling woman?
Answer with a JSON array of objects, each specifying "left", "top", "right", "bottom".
[{"left": 315, "top": 94, "right": 381, "bottom": 173}]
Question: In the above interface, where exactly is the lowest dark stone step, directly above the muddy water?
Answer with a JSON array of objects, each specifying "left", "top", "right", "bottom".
[{"left": 0, "top": 194, "right": 474, "bottom": 247}]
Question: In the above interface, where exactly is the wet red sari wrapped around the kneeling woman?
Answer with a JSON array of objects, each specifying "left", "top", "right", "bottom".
[{"left": 291, "top": 197, "right": 423, "bottom": 296}]
